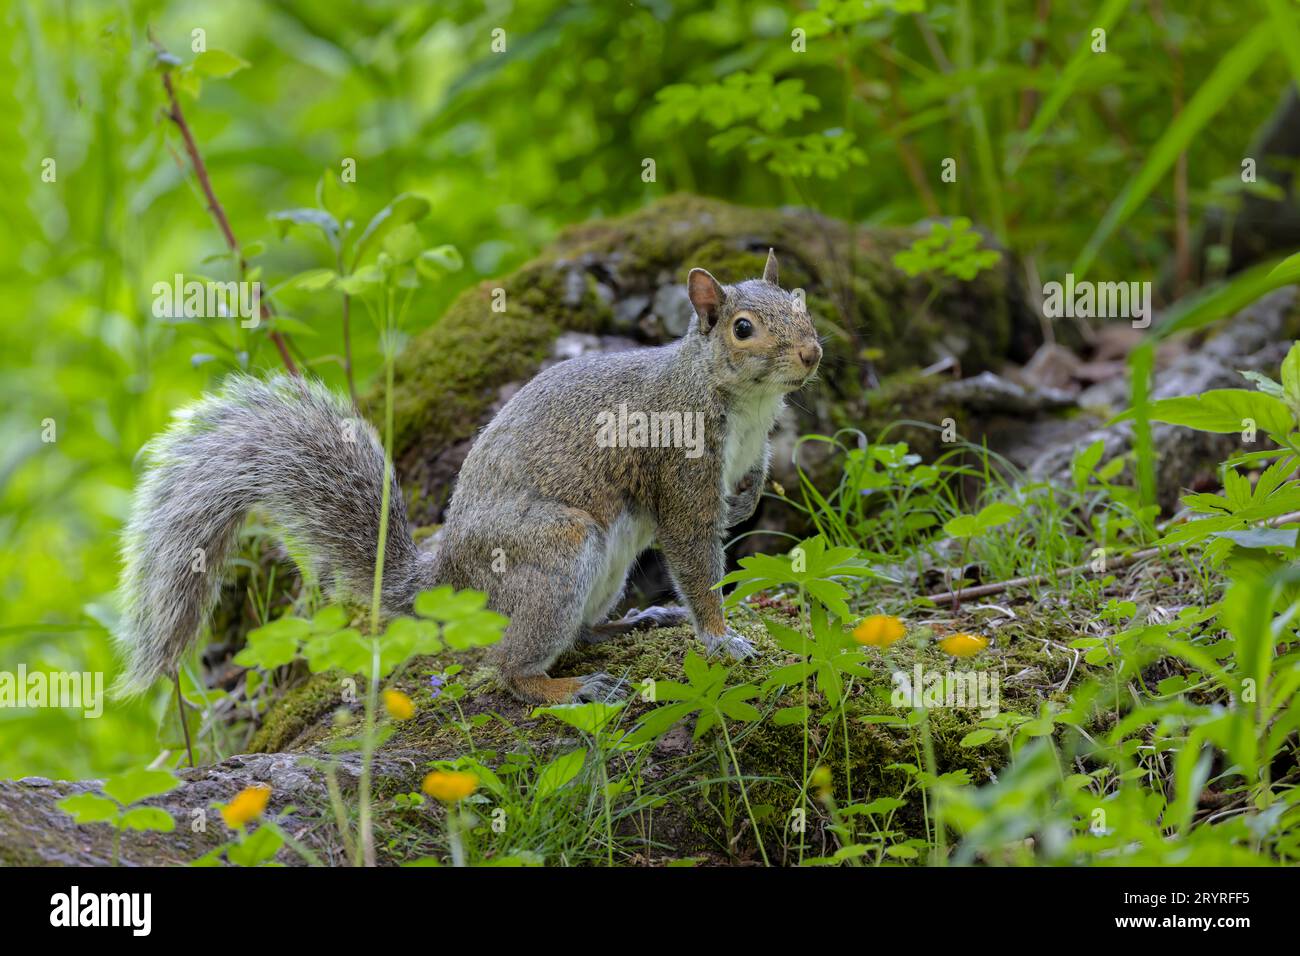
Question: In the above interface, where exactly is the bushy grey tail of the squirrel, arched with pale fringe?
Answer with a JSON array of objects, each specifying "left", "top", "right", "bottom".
[{"left": 116, "top": 375, "right": 433, "bottom": 695}]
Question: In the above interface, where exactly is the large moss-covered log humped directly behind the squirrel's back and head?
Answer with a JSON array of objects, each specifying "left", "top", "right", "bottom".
[{"left": 368, "top": 195, "right": 1041, "bottom": 523}]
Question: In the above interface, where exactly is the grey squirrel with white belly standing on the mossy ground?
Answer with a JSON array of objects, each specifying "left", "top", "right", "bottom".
[{"left": 116, "top": 250, "right": 822, "bottom": 704}]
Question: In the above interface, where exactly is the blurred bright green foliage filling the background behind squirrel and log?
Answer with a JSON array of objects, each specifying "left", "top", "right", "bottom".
[{"left": 0, "top": 0, "right": 1288, "bottom": 777}]
